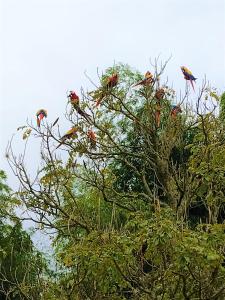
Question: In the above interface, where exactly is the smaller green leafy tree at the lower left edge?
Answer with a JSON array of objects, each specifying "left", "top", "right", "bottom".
[{"left": 0, "top": 171, "right": 46, "bottom": 300}]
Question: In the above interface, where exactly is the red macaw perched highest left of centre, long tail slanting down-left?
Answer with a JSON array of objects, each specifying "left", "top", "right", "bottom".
[{"left": 89, "top": 73, "right": 119, "bottom": 107}]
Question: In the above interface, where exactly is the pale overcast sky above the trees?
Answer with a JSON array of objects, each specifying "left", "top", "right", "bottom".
[{"left": 0, "top": 0, "right": 225, "bottom": 186}]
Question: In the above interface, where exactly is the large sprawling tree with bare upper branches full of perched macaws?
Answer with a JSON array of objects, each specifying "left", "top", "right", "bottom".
[{"left": 8, "top": 64, "right": 225, "bottom": 299}]
